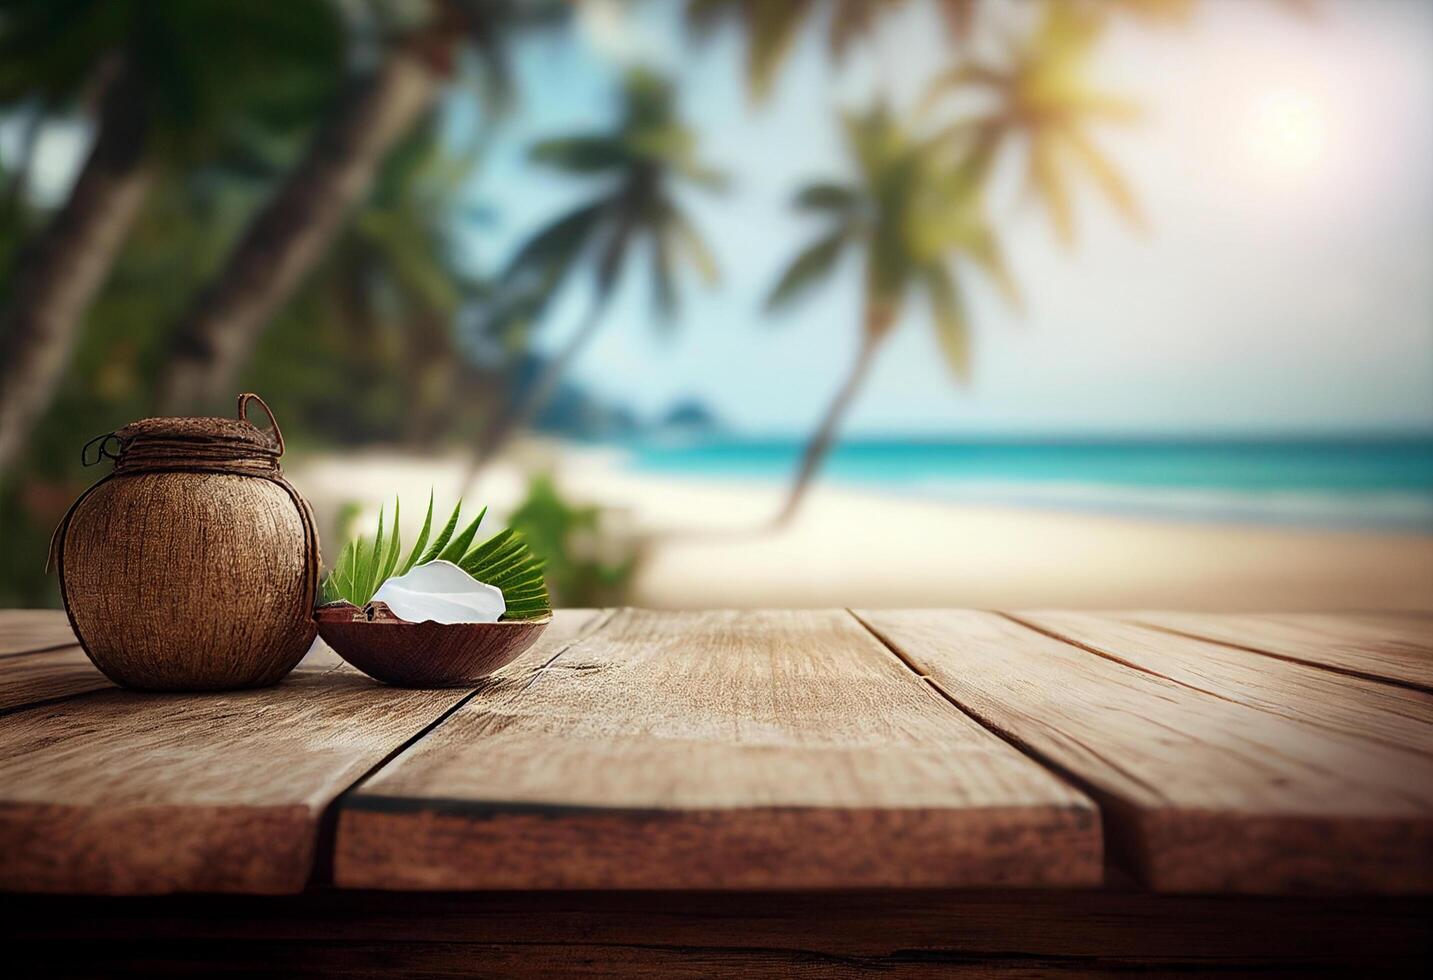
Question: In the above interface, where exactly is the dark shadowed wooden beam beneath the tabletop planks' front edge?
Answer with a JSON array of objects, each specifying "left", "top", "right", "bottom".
[{"left": 0, "top": 890, "right": 1433, "bottom": 980}]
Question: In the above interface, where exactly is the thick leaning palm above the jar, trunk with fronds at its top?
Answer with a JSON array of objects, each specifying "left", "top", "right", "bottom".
[{"left": 160, "top": 0, "right": 565, "bottom": 411}]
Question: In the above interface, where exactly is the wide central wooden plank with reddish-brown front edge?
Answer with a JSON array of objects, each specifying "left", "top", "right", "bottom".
[{"left": 334, "top": 610, "right": 1102, "bottom": 888}]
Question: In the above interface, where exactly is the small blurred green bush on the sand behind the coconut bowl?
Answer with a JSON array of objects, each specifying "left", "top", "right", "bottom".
[{"left": 507, "top": 473, "right": 639, "bottom": 606}]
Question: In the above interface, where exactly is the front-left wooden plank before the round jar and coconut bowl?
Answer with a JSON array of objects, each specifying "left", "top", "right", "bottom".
[{"left": 0, "top": 612, "right": 593, "bottom": 894}]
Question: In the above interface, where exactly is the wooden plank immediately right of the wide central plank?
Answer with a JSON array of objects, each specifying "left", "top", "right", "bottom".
[{"left": 854, "top": 610, "right": 1433, "bottom": 894}]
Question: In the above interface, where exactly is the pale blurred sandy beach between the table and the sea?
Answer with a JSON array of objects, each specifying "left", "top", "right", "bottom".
[{"left": 292, "top": 443, "right": 1433, "bottom": 610}]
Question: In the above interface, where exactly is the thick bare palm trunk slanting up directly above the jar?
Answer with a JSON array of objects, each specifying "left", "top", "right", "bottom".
[{"left": 160, "top": 49, "right": 438, "bottom": 413}]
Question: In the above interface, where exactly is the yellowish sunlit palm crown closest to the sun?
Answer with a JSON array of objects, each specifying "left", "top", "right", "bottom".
[{"left": 926, "top": 0, "right": 1146, "bottom": 244}]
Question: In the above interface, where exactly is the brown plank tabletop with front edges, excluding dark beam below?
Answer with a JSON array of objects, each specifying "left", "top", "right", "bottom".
[{"left": 0, "top": 610, "right": 1433, "bottom": 894}]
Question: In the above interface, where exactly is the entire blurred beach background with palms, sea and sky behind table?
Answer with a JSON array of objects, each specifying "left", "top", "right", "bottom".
[{"left": 0, "top": 0, "right": 1433, "bottom": 610}]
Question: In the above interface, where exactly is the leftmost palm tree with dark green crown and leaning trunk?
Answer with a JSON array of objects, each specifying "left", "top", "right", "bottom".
[{"left": 0, "top": 0, "right": 341, "bottom": 467}]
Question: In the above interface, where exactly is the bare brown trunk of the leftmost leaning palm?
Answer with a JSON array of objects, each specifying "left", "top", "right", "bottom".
[{"left": 0, "top": 66, "right": 155, "bottom": 469}]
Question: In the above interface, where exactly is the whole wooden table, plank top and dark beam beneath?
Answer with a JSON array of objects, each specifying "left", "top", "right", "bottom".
[{"left": 0, "top": 609, "right": 1433, "bottom": 977}]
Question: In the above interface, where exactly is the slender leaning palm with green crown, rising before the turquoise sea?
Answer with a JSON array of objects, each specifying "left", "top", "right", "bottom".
[{"left": 767, "top": 105, "right": 1019, "bottom": 526}]
